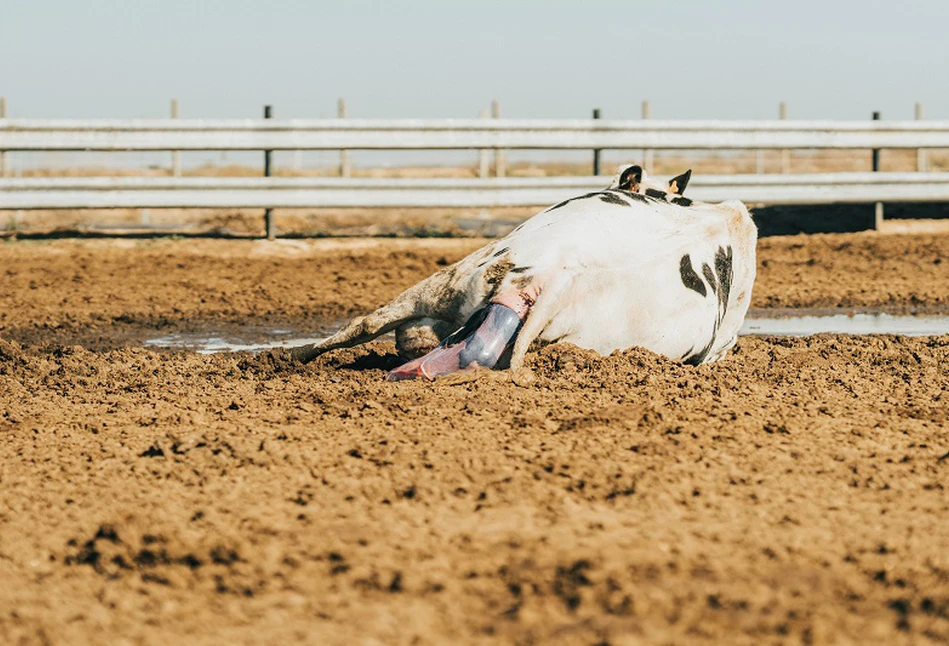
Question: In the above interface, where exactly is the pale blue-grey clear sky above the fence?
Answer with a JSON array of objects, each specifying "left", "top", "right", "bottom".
[{"left": 0, "top": 0, "right": 949, "bottom": 119}]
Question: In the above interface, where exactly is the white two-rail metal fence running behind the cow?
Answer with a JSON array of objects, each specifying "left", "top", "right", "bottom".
[{"left": 0, "top": 117, "right": 949, "bottom": 235}]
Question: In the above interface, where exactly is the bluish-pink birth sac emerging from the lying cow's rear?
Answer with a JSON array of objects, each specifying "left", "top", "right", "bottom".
[{"left": 389, "top": 286, "right": 540, "bottom": 381}]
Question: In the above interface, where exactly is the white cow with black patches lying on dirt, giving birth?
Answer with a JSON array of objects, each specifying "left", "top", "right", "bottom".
[{"left": 292, "top": 166, "right": 757, "bottom": 379}]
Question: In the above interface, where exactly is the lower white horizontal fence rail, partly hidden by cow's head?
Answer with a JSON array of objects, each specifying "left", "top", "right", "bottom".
[{"left": 0, "top": 173, "right": 949, "bottom": 210}]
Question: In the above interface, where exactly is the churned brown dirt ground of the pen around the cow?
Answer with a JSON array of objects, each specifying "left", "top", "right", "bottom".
[{"left": 0, "top": 233, "right": 949, "bottom": 644}]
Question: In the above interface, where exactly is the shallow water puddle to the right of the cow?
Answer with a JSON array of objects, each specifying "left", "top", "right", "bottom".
[{"left": 739, "top": 310, "right": 949, "bottom": 336}]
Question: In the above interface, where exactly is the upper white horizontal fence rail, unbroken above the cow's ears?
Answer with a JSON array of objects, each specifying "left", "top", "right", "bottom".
[{"left": 0, "top": 119, "right": 949, "bottom": 151}]
